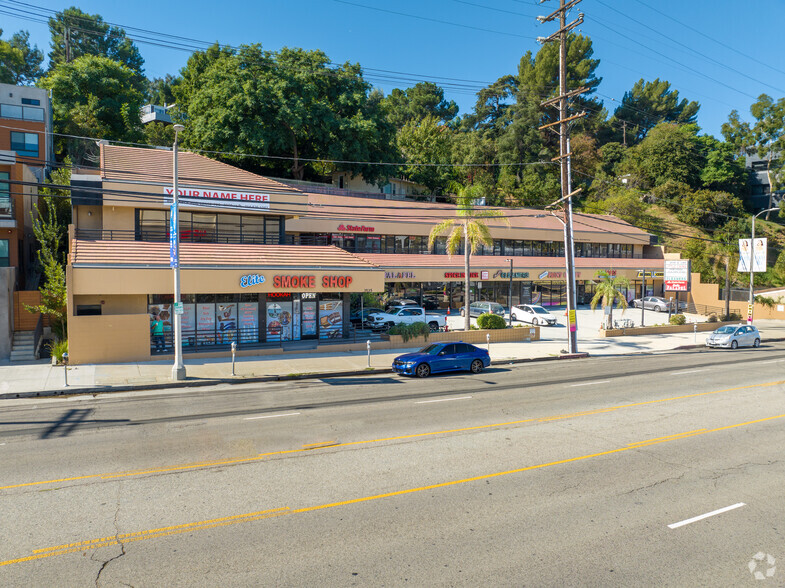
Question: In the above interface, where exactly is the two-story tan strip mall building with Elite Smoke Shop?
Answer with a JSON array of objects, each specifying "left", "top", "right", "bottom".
[{"left": 67, "top": 145, "right": 663, "bottom": 363}]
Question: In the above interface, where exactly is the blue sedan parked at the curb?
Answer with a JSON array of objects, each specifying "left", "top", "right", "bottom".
[{"left": 393, "top": 343, "right": 491, "bottom": 378}]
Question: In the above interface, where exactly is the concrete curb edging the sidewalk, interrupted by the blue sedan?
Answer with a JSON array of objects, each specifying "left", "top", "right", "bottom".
[{"left": 0, "top": 353, "right": 589, "bottom": 400}]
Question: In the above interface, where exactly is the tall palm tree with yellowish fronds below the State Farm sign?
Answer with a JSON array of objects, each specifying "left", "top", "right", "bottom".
[{"left": 428, "top": 185, "right": 510, "bottom": 331}]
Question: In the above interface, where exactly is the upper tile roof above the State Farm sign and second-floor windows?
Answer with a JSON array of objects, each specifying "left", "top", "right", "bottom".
[{"left": 301, "top": 193, "right": 649, "bottom": 240}]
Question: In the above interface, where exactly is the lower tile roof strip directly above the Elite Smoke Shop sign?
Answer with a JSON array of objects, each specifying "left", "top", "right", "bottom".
[{"left": 69, "top": 239, "right": 379, "bottom": 270}]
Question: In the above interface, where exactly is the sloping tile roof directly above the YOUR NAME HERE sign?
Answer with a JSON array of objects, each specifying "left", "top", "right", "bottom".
[{"left": 101, "top": 145, "right": 302, "bottom": 194}]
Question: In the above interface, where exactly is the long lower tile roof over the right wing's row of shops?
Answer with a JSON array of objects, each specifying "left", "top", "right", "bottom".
[{"left": 357, "top": 253, "right": 665, "bottom": 271}]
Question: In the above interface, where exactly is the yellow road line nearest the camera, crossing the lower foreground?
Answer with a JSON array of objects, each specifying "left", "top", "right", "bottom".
[{"left": 0, "top": 414, "right": 785, "bottom": 567}]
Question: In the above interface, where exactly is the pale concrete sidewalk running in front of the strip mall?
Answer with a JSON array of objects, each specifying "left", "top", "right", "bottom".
[{"left": 6, "top": 320, "right": 785, "bottom": 398}]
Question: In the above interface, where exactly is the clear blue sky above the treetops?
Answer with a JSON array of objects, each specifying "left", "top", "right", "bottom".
[{"left": 0, "top": 0, "right": 785, "bottom": 137}]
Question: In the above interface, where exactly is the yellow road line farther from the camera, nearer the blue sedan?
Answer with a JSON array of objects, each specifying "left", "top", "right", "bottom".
[{"left": 0, "top": 380, "right": 785, "bottom": 490}]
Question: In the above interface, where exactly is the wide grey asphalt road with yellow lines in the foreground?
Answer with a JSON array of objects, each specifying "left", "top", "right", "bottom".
[{"left": 0, "top": 343, "right": 785, "bottom": 587}]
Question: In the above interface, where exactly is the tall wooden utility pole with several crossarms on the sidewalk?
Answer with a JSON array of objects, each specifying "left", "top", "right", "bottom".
[{"left": 537, "top": 0, "right": 588, "bottom": 353}]
